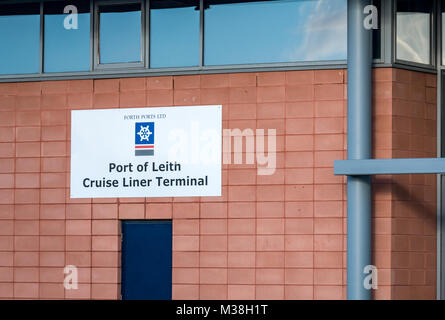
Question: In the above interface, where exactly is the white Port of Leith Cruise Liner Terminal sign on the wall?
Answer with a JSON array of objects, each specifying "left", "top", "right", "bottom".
[{"left": 71, "top": 106, "right": 222, "bottom": 198}]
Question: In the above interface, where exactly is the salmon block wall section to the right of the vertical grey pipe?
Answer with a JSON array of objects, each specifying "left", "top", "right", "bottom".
[{"left": 374, "top": 69, "right": 437, "bottom": 299}]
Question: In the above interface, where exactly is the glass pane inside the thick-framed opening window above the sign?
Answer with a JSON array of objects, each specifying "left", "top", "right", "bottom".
[{"left": 99, "top": 3, "right": 142, "bottom": 63}]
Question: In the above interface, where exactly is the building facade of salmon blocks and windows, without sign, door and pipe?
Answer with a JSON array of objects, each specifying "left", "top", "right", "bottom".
[{"left": 0, "top": 0, "right": 444, "bottom": 299}]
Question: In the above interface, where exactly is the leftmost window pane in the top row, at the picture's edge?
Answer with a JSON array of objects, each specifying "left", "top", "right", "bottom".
[{"left": 0, "top": 3, "right": 40, "bottom": 74}]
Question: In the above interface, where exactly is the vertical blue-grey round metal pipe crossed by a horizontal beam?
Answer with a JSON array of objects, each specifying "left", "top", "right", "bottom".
[{"left": 347, "top": 0, "right": 372, "bottom": 300}]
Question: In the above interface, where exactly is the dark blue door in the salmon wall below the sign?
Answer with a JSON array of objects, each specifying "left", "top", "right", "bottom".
[{"left": 122, "top": 221, "right": 172, "bottom": 300}]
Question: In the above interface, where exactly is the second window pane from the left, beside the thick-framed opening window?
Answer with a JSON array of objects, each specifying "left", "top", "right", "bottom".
[{"left": 43, "top": 1, "right": 91, "bottom": 72}]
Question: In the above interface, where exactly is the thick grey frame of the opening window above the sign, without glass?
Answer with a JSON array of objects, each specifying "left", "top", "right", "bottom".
[{"left": 92, "top": 0, "right": 147, "bottom": 70}]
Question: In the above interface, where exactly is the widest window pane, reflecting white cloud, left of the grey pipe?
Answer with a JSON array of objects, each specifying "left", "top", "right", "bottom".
[{"left": 204, "top": 0, "right": 347, "bottom": 65}]
